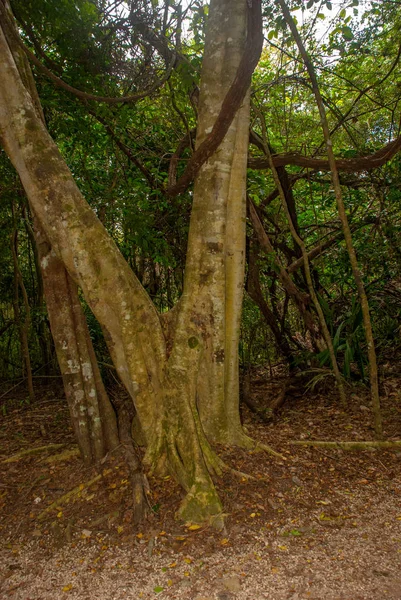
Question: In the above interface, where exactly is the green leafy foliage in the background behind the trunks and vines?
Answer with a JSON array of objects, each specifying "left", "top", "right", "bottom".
[{"left": 0, "top": 0, "right": 401, "bottom": 379}]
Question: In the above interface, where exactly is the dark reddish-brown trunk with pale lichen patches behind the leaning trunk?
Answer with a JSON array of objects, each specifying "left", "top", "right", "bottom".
[{"left": 35, "top": 223, "right": 119, "bottom": 464}]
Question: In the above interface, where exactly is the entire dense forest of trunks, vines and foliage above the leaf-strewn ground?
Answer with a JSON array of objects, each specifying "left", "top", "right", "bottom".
[{"left": 0, "top": 0, "right": 401, "bottom": 527}]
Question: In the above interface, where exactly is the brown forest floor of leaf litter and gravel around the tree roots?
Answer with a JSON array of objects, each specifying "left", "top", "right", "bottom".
[{"left": 0, "top": 371, "right": 401, "bottom": 600}]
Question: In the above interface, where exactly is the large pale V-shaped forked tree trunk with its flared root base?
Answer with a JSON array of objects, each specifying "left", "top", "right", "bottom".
[{"left": 0, "top": 0, "right": 250, "bottom": 521}]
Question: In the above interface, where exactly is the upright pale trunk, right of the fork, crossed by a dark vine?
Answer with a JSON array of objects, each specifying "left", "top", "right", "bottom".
[{"left": 176, "top": 0, "right": 249, "bottom": 443}]
